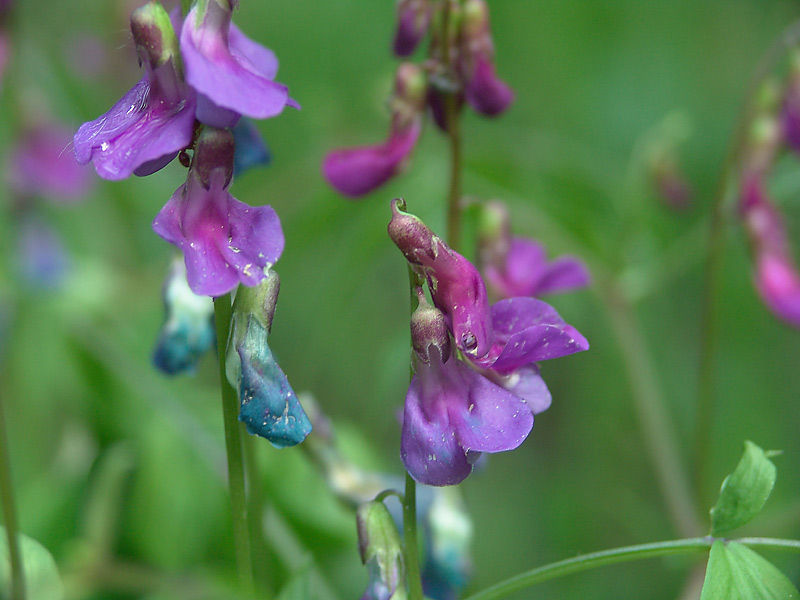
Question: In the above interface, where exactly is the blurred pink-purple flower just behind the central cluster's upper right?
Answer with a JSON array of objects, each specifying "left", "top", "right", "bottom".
[{"left": 479, "top": 202, "right": 590, "bottom": 298}]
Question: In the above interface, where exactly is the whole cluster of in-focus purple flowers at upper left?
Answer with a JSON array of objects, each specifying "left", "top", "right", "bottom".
[{"left": 74, "top": 0, "right": 298, "bottom": 296}]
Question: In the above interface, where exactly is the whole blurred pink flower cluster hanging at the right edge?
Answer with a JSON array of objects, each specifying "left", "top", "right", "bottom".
[{"left": 739, "top": 69, "right": 800, "bottom": 327}]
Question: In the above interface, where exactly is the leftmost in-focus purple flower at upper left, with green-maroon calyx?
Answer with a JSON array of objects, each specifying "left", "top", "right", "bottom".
[{"left": 74, "top": 2, "right": 195, "bottom": 180}]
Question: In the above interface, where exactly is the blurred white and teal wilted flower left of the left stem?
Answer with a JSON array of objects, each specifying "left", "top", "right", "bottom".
[{"left": 153, "top": 259, "right": 216, "bottom": 375}]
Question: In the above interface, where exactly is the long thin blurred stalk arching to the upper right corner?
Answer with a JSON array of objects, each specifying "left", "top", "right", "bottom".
[{"left": 693, "top": 16, "right": 800, "bottom": 505}]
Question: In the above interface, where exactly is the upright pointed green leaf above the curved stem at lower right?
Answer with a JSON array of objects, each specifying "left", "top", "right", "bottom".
[{"left": 711, "top": 441, "right": 776, "bottom": 537}]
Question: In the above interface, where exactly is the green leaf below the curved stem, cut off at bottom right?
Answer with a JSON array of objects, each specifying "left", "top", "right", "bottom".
[{"left": 700, "top": 540, "right": 800, "bottom": 600}]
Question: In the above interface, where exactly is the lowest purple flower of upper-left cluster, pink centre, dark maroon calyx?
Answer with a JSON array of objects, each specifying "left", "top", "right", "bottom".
[{"left": 153, "top": 127, "right": 284, "bottom": 296}]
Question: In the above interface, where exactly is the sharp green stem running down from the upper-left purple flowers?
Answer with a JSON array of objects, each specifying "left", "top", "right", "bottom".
[{"left": 214, "top": 294, "right": 253, "bottom": 594}]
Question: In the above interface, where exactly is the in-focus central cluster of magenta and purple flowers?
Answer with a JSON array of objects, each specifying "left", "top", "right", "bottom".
[{"left": 389, "top": 200, "right": 589, "bottom": 485}]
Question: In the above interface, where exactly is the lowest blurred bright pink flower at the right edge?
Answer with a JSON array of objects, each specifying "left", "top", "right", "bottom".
[{"left": 739, "top": 177, "right": 800, "bottom": 328}]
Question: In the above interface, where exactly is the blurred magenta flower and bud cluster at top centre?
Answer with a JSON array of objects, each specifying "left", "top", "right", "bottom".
[{"left": 322, "top": 0, "right": 514, "bottom": 198}]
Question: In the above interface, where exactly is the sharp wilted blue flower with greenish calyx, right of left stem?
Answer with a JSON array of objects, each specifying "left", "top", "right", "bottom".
[{"left": 227, "top": 270, "right": 311, "bottom": 448}]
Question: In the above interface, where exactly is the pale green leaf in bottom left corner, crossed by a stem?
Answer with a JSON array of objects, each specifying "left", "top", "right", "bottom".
[{"left": 0, "top": 527, "right": 64, "bottom": 600}]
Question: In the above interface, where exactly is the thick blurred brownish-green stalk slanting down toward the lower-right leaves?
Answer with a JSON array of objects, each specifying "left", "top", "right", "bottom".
[{"left": 601, "top": 282, "right": 702, "bottom": 537}]
